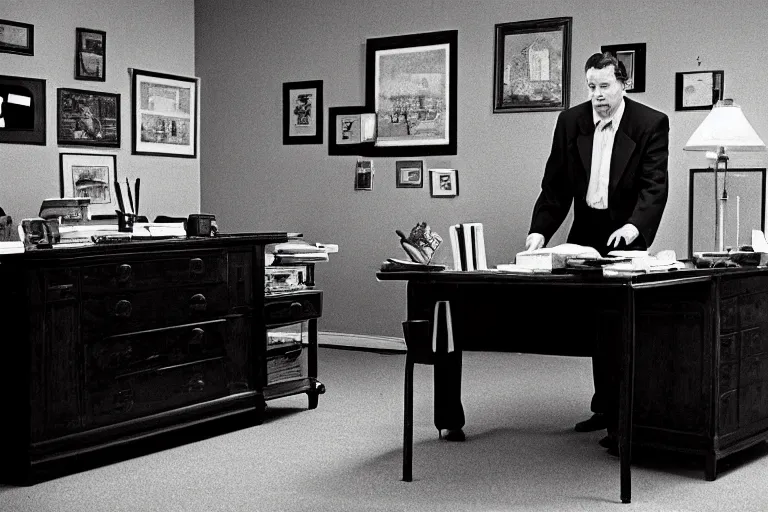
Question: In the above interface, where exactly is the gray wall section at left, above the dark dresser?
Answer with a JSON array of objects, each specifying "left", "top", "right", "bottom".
[{"left": 0, "top": 0, "right": 200, "bottom": 223}]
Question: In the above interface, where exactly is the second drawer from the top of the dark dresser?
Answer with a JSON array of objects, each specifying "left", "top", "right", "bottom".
[{"left": 82, "top": 283, "right": 229, "bottom": 340}]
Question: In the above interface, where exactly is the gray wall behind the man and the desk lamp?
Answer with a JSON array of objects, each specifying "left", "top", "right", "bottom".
[{"left": 195, "top": 0, "right": 768, "bottom": 336}]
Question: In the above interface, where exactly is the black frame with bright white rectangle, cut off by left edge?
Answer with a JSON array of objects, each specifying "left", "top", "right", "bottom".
[{"left": 0, "top": 75, "right": 46, "bottom": 146}]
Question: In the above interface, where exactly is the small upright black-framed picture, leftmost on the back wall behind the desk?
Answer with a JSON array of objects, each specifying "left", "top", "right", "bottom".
[{"left": 283, "top": 80, "right": 324, "bottom": 145}]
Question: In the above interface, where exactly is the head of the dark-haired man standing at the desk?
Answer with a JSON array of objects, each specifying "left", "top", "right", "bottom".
[{"left": 584, "top": 53, "right": 627, "bottom": 119}]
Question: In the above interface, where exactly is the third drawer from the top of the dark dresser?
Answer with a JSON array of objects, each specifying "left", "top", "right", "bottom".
[{"left": 85, "top": 319, "right": 227, "bottom": 384}]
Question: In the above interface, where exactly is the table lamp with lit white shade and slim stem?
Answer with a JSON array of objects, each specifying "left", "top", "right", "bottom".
[{"left": 683, "top": 99, "right": 766, "bottom": 252}]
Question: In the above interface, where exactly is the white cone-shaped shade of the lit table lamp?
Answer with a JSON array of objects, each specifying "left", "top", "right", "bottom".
[{"left": 683, "top": 100, "right": 765, "bottom": 151}]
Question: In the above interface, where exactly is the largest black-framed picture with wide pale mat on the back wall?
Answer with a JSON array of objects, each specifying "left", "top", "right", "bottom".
[{"left": 365, "top": 30, "right": 459, "bottom": 157}]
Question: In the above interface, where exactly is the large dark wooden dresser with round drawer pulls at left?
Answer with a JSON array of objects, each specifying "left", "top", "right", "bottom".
[{"left": 0, "top": 233, "right": 321, "bottom": 483}]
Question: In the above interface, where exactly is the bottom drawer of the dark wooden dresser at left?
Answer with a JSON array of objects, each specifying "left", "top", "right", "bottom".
[{"left": 87, "top": 357, "right": 228, "bottom": 427}]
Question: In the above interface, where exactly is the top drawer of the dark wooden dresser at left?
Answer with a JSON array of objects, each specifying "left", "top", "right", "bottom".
[{"left": 82, "top": 251, "right": 227, "bottom": 295}]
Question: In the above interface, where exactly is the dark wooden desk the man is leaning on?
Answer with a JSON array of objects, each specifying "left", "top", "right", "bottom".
[{"left": 376, "top": 268, "right": 768, "bottom": 503}]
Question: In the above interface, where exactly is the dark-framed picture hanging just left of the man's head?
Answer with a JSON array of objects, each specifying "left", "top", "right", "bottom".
[{"left": 493, "top": 17, "right": 573, "bottom": 114}]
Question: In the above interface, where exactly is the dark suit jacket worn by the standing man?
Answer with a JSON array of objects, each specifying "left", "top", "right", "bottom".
[{"left": 529, "top": 96, "right": 669, "bottom": 248}]
